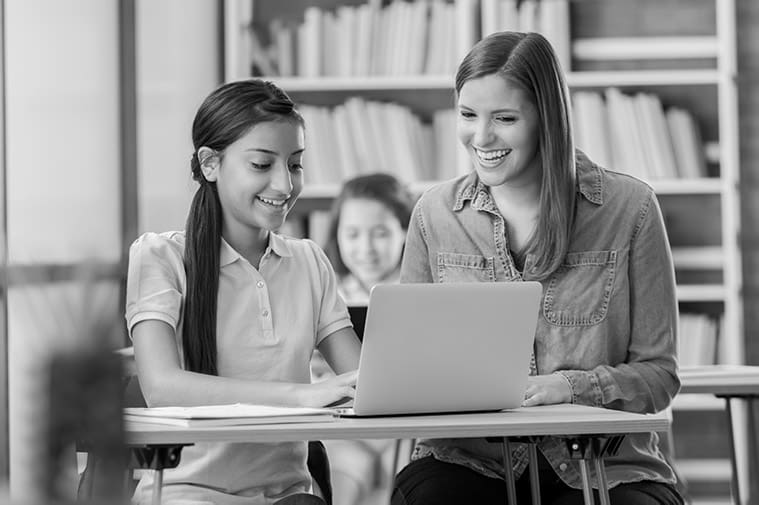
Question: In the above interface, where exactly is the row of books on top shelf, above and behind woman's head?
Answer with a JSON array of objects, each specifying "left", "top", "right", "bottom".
[{"left": 252, "top": 0, "right": 570, "bottom": 77}]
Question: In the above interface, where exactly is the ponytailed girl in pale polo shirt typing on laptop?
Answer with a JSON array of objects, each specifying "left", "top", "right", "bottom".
[{"left": 126, "top": 80, "right": 359, "bottom": 504}]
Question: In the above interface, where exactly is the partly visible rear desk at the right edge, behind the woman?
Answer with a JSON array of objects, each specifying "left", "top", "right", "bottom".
[{"left": 679, "top": 365, "right": 759, "bottom": 505}]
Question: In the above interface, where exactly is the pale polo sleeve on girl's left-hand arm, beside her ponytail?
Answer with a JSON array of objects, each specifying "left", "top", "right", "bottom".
[{"left": 125, "top": 233, "right": 185, "bottom": 337}]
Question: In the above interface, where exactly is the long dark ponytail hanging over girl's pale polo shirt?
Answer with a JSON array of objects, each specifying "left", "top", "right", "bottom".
[{"left": 182, "top": 153, "right": 221, "bottom": 375}]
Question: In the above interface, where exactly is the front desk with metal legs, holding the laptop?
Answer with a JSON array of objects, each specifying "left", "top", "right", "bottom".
[{"left": 126, "top": 405, "right": 670, "bottom": 505}]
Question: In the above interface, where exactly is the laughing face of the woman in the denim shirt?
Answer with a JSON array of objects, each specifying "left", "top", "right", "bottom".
[{"left": 456, "top": 74, "right": 541, "bottom": 187}]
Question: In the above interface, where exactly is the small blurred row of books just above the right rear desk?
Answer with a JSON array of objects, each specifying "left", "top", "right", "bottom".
[{"left": 677, "top": 312, "right": 722, "bottom": 367}]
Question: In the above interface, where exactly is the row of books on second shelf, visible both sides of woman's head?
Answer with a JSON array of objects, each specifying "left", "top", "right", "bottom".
[{"left": 300, "top": 88, "right": 707, "bottom": 184}]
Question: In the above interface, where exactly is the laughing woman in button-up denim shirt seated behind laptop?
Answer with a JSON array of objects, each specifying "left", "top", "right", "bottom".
[{"left": 392, "top": 32, "right": 683, "bottom": 505}]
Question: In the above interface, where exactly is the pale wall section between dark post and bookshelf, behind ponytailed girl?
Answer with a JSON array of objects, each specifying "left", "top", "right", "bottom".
[{"left": 137, "top": 0, "right": 221, "bottom": 232}]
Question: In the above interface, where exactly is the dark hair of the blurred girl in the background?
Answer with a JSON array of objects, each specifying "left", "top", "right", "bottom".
[{"left": 324, "top": 173, "right": 415, "bottom": 275}]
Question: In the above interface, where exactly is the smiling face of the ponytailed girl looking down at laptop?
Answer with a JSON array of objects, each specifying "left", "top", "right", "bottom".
[{"left": 206, "top": 120, "right": 305, "bottom": 233}]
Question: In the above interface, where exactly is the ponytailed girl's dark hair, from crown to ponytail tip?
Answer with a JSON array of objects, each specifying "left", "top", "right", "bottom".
[{"left": 182, "top": 79, "right": 303, "bottom": 375}]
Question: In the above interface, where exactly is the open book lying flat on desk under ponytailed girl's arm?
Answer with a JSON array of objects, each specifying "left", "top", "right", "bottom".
[{"left": 124, "top": 403, "right": 336, "bottom": 428}]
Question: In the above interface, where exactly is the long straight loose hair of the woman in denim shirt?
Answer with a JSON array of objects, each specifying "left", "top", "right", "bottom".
[{"left": 456, "top": 32, "right": 576, "bottom": 279}]
